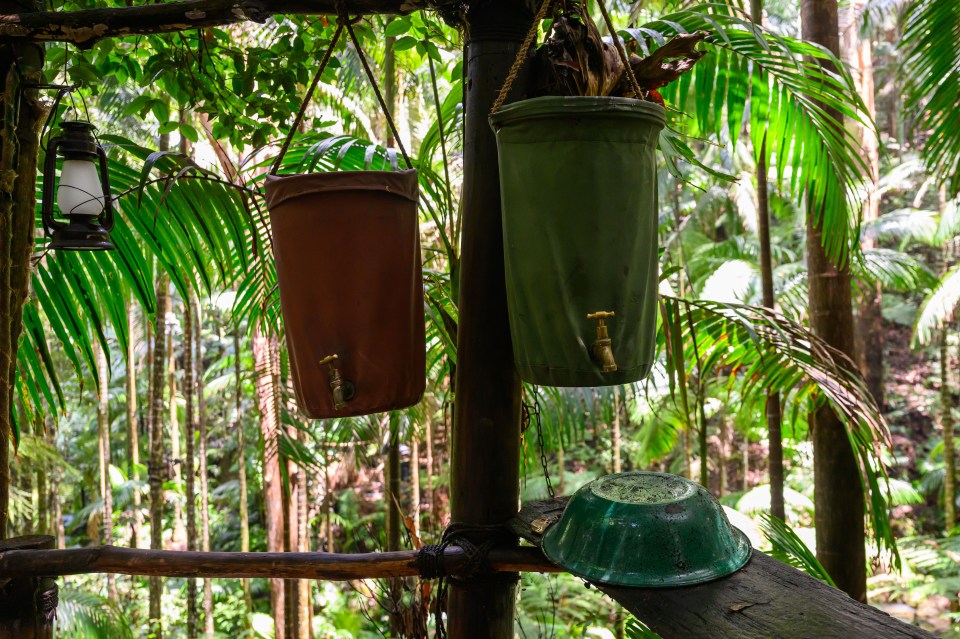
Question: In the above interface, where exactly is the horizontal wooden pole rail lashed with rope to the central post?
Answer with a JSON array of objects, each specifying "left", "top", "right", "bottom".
[{"left": 0, "top": 540, "right": 559, "bottom": 581}]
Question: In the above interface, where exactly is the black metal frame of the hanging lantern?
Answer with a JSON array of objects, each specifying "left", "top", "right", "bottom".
[{"left": 41, "top": 120, "right": 116, "bottom": 251}]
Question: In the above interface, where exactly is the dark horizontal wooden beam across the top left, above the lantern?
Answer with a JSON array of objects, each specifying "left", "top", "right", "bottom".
[{"left": 0, "top": 0, "right": 435, "bottom": 47}]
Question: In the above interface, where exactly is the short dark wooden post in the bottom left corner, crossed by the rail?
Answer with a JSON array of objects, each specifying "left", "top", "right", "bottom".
[{"left": 0, "top": 535, "right": 57, "bottom": 639}]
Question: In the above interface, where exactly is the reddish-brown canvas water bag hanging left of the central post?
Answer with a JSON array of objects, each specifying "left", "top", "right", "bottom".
[{"left": 266, "top": 169, "right": 426, "bottom": 419}]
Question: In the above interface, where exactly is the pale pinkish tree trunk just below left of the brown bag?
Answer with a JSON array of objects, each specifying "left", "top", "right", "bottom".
[{"left": 253, "top": 326, "right": 286, "bottom": 639}]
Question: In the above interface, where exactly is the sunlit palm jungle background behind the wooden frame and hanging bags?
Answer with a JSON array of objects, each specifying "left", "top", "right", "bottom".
[{"left": 1, "top": 0, "right": 960, "bottom": 639}]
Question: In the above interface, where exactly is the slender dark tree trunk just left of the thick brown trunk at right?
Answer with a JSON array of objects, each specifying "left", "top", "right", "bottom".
[{"left": 750, "top": 0, "right": 786, "bottom": 520}]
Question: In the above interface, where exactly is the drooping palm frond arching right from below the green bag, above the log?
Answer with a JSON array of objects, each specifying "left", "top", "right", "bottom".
[{"left": 658, "top": 296, "right": 897, "bottom": 561}]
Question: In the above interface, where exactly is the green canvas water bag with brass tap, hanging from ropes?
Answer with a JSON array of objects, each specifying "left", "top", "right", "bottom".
[{"left": 490, "top": 96, "right": 665, "bottom": 386}]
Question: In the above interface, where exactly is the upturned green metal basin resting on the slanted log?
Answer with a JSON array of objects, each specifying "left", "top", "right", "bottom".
[{"left": 543, "top": 472, "right": 750, "bottom": 588}]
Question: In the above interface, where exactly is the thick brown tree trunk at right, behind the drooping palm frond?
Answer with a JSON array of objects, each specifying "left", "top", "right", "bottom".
[{"left": 801, "top": 0, "right": 867, "bottom": 601}]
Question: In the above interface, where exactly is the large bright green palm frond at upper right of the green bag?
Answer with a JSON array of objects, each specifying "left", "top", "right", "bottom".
[{"left": 627, "top": 3, "right": 873, "bottom": 263}]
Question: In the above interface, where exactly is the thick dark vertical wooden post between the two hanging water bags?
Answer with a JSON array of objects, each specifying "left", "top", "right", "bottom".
[{"left": 447, "top": 0, "right": 533, "bottom": 639}]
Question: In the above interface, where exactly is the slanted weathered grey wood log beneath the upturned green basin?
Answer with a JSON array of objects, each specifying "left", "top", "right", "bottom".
[{"left": 510, "top": 497, "right": 933, "bottom": 639}]
